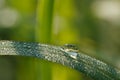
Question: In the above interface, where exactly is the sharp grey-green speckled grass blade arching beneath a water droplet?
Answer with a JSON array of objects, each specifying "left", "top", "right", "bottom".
[{"left": 0, "top": 41, "right": 120, "bottom": 80}]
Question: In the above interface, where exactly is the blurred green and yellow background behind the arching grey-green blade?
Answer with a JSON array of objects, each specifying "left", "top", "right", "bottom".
[{"left": 0, "top": 0, "right": 120, "bottom": 80}]
